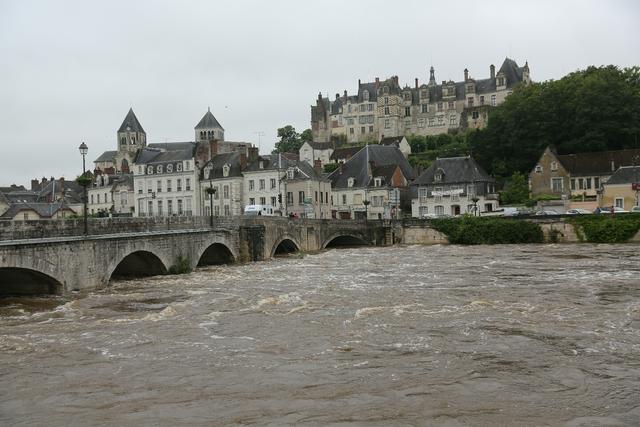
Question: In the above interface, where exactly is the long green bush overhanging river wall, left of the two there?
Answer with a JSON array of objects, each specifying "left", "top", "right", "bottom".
[{"left": 431, "top": 215, "right": 543, "bottom": 245}]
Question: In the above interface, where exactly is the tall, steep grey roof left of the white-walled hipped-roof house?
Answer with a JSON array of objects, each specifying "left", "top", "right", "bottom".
[{"left": 329, "top": 144, "right": 413, "bottom": 188}]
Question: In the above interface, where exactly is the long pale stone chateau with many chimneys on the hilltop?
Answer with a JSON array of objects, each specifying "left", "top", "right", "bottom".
[{"left": 311, "top": 58, "right": 531, "bottom": 142}]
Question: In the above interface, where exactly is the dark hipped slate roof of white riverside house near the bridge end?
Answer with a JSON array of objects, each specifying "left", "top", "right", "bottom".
[{"left": 413, "top": 156, "right": 495, "bottom": 185}]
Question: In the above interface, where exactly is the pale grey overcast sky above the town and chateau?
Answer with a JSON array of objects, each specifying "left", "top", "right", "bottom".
[{"left": 0, "top": 0, "right": 640, "bottom": 186}]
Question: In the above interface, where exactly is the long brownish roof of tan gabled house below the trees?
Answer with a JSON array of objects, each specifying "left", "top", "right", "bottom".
[{"left": 556, "top": 149, "right": 640, "bottom": 176}]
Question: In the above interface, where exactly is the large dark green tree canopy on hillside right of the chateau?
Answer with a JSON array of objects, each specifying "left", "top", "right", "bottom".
[{"left": 469, "top": 65, "right": 640, "bottom": 179}]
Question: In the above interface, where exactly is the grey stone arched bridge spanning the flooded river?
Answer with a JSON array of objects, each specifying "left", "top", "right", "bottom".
[{"left": 0, "top": 217, "right": 396, "bottom": 294}]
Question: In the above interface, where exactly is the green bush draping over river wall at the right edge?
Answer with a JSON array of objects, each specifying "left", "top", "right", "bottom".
[{"left": 569, "top": 214, "right": 640, "bottom": 243}]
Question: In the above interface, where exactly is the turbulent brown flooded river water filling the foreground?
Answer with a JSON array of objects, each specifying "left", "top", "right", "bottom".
[{"left": 0, "top": 244, "right": 640, "bottom": 426}]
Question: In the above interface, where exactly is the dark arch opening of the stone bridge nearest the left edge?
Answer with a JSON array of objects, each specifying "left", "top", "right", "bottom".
[{"left": 0, "top": 267, "right": 64, "bottom": 296}]
